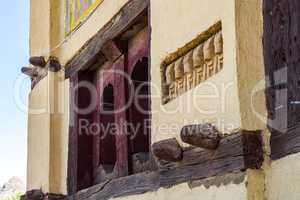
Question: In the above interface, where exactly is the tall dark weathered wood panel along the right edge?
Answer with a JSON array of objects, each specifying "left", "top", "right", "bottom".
[{"left": 263, "top": 0, "right": 300, "bottom": 160}]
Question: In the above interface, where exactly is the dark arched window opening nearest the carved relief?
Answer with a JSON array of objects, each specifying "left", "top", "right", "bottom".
[{"left": 127, "top": 58, "right": 150, "bottom": 174}]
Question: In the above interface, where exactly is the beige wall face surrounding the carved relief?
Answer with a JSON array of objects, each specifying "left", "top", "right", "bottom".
[{"left": 151, "top": 0, "right": 241, "bottom": 145}]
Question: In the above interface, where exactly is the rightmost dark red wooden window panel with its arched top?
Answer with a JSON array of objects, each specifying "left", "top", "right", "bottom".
[{"left": 126, "top": 27, "right": 151, "bottom": 173}]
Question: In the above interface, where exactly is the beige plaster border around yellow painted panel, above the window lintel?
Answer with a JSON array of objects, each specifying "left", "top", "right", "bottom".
[{"left": 51, "top": 0, "right": 128, "bottom": 65}]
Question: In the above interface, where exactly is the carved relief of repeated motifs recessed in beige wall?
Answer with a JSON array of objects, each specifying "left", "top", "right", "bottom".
[{"left": 161, "top": 22, "right": 223, "bottom": 104}]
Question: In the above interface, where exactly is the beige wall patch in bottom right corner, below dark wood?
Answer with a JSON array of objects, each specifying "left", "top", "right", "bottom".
[{"left": 266, "top": 153, "right": 300, "bottom": 200}]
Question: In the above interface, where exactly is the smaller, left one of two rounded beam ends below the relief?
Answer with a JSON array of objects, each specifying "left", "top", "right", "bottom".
[{"left": 152, "top": 138, "right": 183, "bottom": 162}]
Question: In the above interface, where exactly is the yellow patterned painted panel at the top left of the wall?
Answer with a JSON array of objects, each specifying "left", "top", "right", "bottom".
[{"left": 65, "top": 0, "right": 103, "bottom": 34}]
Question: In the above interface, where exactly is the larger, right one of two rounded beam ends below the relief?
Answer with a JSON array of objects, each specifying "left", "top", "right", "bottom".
[{"left": 180, "top": 124, "right": 221, "bottom": 149}]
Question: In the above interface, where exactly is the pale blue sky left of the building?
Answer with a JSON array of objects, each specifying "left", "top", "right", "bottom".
[{"left": 0, "top": 0, "right": 30, "bottom": 185}]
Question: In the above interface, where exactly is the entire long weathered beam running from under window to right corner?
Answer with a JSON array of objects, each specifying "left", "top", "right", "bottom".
[{"left": 68, "top": 131, "right": 263, "bottom": 200}]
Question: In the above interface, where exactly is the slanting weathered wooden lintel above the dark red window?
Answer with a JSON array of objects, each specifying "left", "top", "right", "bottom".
[{"left": 65, "top": 0, "right": 149, "bottom": 78}]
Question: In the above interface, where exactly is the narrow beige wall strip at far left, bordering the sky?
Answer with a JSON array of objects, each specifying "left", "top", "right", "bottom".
[{"left": 27, "top": 0, "right": 50, "bottom": 191}]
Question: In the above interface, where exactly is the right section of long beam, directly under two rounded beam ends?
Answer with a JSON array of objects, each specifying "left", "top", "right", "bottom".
[{"left": 160, "top": 131, "right": 263, "bottom": 187}]
